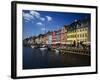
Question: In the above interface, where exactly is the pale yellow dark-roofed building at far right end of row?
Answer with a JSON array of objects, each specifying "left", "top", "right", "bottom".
[{"left": 76, "top": 19, "right": 90, "bottom": 44}]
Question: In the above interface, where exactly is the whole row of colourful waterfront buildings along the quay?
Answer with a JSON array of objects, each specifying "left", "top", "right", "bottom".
[{"left": 29, "top": 19, "right": 91, "bottom": 48}]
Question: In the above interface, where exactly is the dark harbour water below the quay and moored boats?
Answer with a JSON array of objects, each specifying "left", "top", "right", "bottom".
[{"left": 23, "top": 47, "right": 90, "bottom": 69}]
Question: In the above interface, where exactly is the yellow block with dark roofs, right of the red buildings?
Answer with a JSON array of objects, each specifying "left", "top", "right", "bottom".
[{"left": 67, "top": 18, "right": 90, "bottom": 45}]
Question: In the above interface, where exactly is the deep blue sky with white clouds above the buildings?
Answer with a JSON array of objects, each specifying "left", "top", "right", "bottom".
[{"left": 22, "top": 10, "right": 90, "bottom": 39}]
